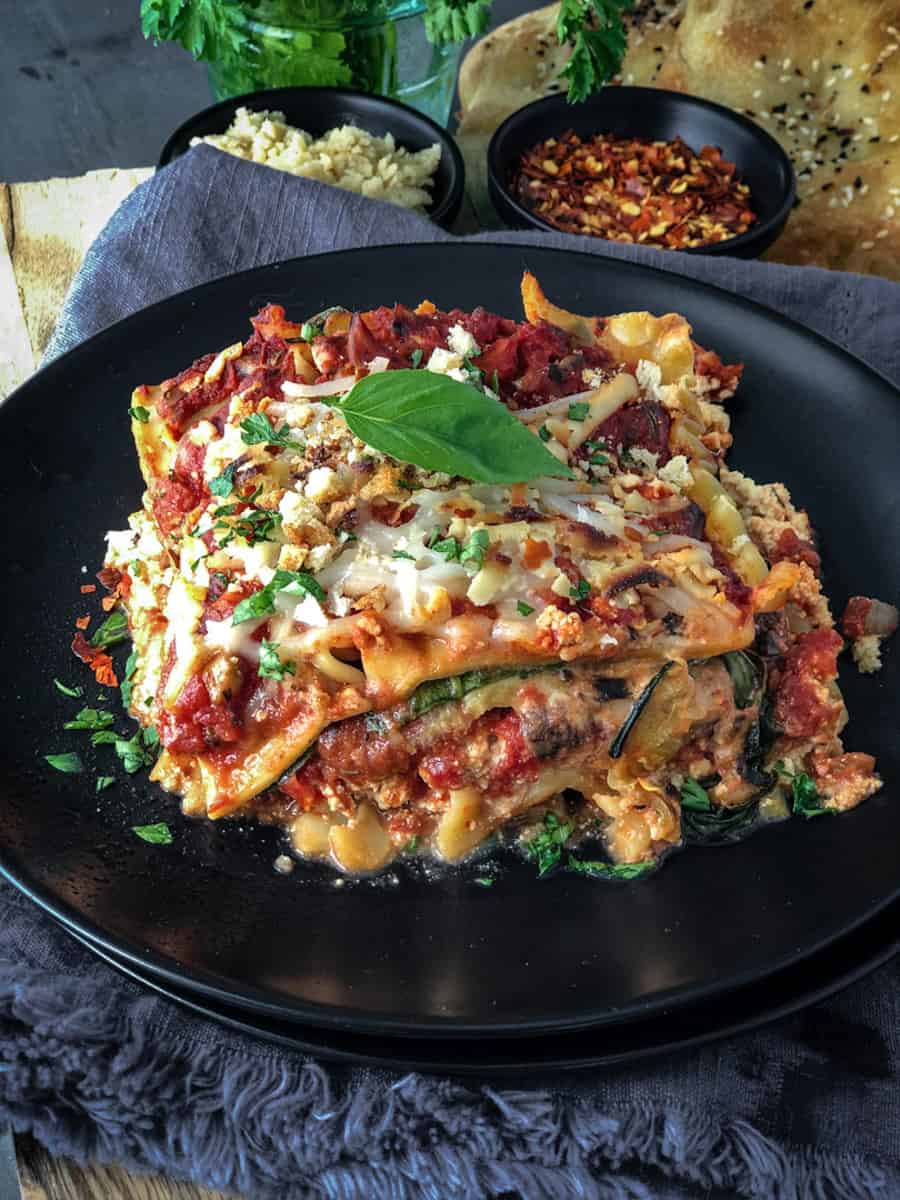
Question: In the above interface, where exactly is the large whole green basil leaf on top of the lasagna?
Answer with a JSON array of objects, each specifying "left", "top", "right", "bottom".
[{"left": 332, "top": 371, "right": 574, "bottom": 484}]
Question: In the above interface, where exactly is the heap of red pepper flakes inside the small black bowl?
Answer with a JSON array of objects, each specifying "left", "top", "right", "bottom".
[{"left": 512, "top": 130, "right": 757, "bottom": 250}]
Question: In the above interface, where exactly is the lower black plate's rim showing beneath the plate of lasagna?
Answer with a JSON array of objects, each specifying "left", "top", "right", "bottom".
[{"left": 64, "top": 902, "right": 900, "bottom": 1081}]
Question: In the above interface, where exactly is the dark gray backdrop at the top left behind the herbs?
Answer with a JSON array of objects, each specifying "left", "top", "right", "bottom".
[{"left": 0, "top": 0, "right": 520, "bottom": 182}]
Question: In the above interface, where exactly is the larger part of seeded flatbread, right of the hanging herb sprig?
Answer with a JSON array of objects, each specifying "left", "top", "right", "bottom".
[{"left": 658, "top": 0, "right": 900, "bottom": 278}]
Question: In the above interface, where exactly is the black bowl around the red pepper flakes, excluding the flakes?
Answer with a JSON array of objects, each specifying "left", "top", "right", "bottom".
[{"left": 487, "top": 88, "right": 796, "bottom": 258}]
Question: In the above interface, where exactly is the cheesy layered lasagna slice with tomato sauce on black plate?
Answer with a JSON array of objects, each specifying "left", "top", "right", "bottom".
[{"left": 103, "top": 275, "right": 880, "bottom": 871}]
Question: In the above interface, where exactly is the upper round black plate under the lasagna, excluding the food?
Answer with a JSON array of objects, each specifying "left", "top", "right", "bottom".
[{"left": 0, "top": 238, "right": 900, "bottom": 1037}]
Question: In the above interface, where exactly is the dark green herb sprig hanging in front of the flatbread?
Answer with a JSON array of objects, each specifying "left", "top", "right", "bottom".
[{"left": 557, "top": 0, "right": 632, "bottom": 103}]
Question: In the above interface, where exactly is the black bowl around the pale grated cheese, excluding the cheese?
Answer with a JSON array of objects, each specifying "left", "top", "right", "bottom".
[{"left": 157, "top": 88, "right": 466, "bottom": 229}]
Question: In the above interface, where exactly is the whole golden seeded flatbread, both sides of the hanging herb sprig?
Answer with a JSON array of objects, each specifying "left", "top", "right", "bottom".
[{"left": 460, "top": 0, "right": 900, "bottom": 280}]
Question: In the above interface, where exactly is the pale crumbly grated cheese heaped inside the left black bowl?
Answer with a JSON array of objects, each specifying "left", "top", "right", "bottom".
[{"left": 191, "top": 108, "right": 440, "bottom": 211}]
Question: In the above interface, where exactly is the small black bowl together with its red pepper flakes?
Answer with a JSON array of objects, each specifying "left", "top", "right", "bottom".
[{"left": 487, "top": 88, "right": 794, "bottom": 258}]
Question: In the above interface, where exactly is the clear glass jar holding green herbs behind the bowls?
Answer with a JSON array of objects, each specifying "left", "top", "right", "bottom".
[{"left": 209, "top": 0, "right": 461, "bottom": 125}]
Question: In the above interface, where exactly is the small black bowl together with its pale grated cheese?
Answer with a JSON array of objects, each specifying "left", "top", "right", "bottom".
[{"left": 157, "top": 88, "right": 464, "bottom": 228}]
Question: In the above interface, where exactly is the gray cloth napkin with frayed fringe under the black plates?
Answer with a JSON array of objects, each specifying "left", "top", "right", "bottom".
[{"left": 0, "top": 146, "right": 900, "bottom": 1200}]
